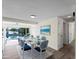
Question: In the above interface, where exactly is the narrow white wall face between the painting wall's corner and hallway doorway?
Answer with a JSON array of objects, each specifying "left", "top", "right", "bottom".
[{"left": 57, "top": 18, "right": 63, "bottom": 49}]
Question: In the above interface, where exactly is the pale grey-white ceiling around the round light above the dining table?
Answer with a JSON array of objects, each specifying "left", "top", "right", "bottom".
[{"left": 2, "top": 0, "right": 76, "bottom": 22}]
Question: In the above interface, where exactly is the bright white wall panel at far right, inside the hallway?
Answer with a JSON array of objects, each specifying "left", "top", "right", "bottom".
[{"left": 69, "top": 22, "right": 76, "bottom": 43}]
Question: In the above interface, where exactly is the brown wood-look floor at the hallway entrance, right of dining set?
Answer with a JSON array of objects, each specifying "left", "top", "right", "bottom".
[{"left": 52, "top": 45, "right": 75, "bottom": 59}]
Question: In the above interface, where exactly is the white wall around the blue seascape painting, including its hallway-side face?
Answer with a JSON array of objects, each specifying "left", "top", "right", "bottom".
[{"left": 38, "top": 17, "right": 63, "bottom": 50}]
